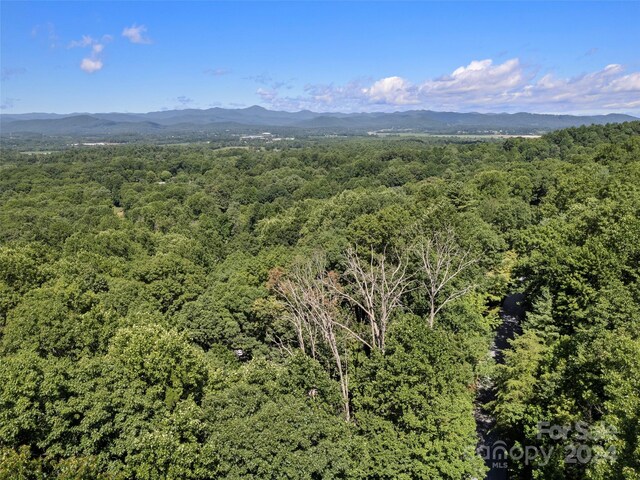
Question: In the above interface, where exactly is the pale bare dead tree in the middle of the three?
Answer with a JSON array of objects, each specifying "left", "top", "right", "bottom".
[{"left": 329, "top": 248, "right": 411, "bottom": 352}]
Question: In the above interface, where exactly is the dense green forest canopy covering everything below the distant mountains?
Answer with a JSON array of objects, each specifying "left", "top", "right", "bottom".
[{"left": 0, "top": 122, "right": 640, "bottom": 480}]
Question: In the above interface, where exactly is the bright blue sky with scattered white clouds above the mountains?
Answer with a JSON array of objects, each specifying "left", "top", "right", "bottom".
[{"left": 0, "top": 0, "right": 640, "bottom": 115}]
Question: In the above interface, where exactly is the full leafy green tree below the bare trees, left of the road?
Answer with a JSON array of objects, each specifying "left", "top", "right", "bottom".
[{"left": 354, "top": 316, "right": 484, "bottom": 479}]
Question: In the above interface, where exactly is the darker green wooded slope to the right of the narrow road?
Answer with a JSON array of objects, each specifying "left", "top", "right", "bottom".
[{"left": 495, "top": 124, "right": 640, "bottom": 479}]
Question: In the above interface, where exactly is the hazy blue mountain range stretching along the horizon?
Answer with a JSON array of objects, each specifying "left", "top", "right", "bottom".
[{"left": 0, "top": 106, "right": 638, "bottom": 136}]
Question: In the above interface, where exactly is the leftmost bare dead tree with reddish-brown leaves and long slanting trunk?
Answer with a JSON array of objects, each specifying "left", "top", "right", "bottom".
[{"left": 273, "top": 254, "right": 358, "bottom": 421}]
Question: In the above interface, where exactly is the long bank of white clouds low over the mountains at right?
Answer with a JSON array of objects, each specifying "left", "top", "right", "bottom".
[{"left": 256, "top": 58, "right": 640, "bottom": 112}]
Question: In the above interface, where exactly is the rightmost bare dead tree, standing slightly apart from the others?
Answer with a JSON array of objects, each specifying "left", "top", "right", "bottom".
[{"left": 413, "top": 226, "right": 479, "bottom": 328}]
